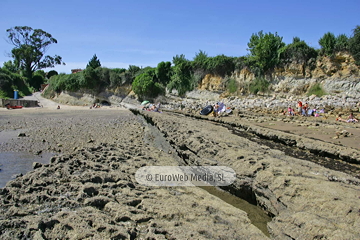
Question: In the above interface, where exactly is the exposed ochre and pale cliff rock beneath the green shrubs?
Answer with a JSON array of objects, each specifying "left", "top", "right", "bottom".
[{"left": 198, "top": 53, "right": 360, "bottom": 96}]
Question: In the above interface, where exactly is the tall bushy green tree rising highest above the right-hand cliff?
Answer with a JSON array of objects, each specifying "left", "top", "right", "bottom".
[{"left": 248, "top": 31, "right": 285, "bottom": 75}]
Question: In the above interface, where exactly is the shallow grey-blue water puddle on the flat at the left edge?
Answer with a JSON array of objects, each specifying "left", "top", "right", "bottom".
[{"left": 0, "top": 152, "right": 54, "bottom": 188}]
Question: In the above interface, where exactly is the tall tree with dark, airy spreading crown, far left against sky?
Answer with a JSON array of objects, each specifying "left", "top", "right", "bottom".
[{"left": 6, "top": 26, "right": 65, "bottom": 85}]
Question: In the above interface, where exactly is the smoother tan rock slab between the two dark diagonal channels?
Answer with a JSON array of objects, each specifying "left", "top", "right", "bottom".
[{"left": 139, "top": 110, "right": 360, "bottom": 239}]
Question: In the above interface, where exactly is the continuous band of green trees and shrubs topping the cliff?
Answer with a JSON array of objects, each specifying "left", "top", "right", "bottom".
[{"left": 0, "top": 26, "right": 360, "bottom": 99}]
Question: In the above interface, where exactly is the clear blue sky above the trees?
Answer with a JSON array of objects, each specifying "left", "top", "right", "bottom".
[{"left": 0, "top": 0, "right": 360, "bottom": 73}]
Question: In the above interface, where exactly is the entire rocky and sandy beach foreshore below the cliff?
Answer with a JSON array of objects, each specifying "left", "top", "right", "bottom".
[{"left": 0, "top": 96, "right": 360, "bottom": 239}]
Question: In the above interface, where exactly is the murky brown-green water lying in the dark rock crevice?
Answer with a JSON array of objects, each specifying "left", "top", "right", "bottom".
[{"left": 199, "top": 187, "right": 271, "bottom": 237}]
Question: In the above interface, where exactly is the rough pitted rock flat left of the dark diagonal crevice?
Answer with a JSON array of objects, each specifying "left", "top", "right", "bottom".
[{"left": 0, "top": 109, "right": 268, "bottom": 240}]
